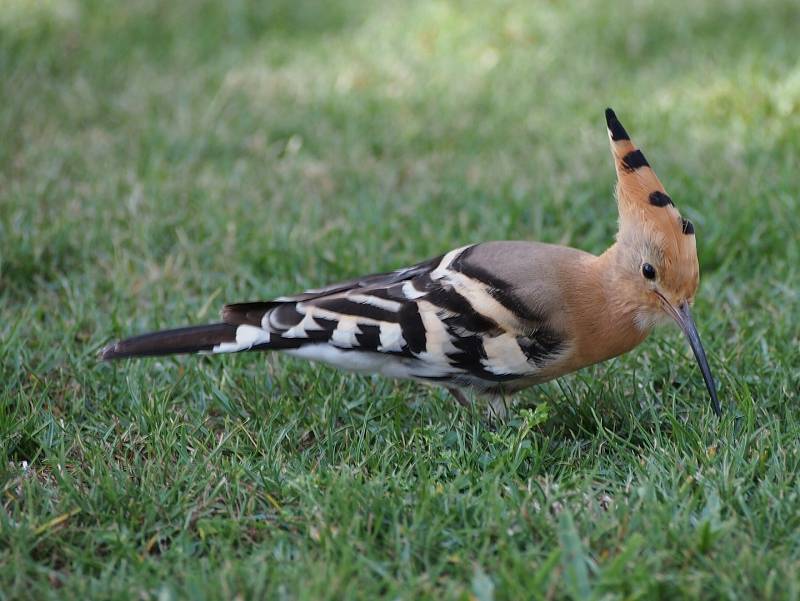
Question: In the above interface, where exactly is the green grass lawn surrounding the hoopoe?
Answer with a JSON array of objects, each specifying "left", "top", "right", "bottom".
[{"left": 0, "top": 0, "right": 800, "bottom": 601}]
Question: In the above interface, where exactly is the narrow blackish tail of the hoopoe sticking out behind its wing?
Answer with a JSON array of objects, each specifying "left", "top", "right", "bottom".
[{"left": 100, "top": 323, "right": 237, "bottom": 361}]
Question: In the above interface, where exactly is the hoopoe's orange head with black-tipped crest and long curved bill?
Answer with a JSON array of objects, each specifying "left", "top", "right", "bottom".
[{"left": 606, "top": 109, "right": 720, "bottom": 415}]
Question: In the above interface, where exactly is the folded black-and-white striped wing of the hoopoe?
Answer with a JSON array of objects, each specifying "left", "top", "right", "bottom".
[{"left": 214, "top": 247, "right": 563, "bottom": 389}]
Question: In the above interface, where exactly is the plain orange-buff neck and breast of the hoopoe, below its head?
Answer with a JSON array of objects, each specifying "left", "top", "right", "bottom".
[{"left": 572, "top": 243, "right": 650, "bottom": 365}]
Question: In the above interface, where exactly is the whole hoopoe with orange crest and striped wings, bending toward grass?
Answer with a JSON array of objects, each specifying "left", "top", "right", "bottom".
[{"left": 102, "top": 109, "right": 720, "bottom": 415}]
